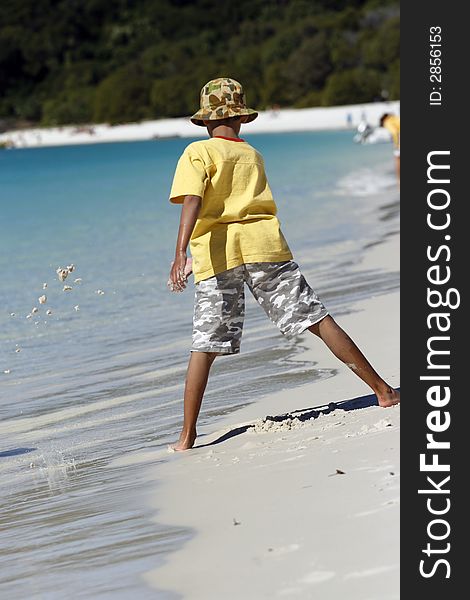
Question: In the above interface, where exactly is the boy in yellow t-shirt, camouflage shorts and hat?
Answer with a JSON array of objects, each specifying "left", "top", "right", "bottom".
[{"left": 169, "top": 78, "right": 399, "bottom": 450}]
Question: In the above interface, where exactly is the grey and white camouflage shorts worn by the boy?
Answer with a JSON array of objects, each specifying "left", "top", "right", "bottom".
[{"left": 191, "top": 261, "right": 328, "bottom": 354}]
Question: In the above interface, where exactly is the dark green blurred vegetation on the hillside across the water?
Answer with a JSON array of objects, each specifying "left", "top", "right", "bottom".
[{"left": 0, "top": 0, "right": 400, "bottom": 125}]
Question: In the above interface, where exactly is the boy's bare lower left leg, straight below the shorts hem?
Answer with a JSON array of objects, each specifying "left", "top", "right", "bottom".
[{"left": 171, "top": 352, "right": 217, "bottom": 450}]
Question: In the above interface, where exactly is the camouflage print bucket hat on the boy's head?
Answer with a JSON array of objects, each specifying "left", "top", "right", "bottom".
[{"left": 191, "top": 77, "right": 258, "bottom": 127}]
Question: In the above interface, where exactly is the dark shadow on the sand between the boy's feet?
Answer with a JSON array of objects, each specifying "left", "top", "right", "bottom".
[{"left": 194, "top": 387, "right": 400, "bottom": 449}]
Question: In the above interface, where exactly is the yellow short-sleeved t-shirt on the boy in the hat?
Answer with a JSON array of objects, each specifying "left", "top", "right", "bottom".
[{"left": 170, "top": 137, "right": 292, "bottom": 282}]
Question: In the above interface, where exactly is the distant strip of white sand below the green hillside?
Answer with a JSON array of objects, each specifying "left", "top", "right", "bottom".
[{"left": 0, "top": 102, "right": 400, "bottom": 148}]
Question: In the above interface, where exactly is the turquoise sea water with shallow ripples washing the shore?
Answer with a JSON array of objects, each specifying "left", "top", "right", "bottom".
[{"left": 0, "top": 132, "right": 398, "bottom": 599}]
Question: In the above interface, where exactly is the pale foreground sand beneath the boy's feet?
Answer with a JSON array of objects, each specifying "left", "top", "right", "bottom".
[{"left": 137, "top": 236, "right": 400, "bottom": 600}]
